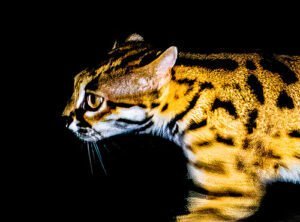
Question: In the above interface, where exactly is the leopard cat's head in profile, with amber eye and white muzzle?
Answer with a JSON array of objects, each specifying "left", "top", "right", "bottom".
[{"left": 63, "top": 34, "right": 177, "bottom": 141}]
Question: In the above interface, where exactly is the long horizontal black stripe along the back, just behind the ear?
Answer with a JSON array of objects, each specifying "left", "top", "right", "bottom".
[{"left": 176, "top": 58, "right": 239, "bottom": 71}]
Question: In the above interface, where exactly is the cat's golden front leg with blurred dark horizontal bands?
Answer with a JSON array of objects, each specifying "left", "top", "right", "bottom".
[{"left": 177, "top": 149, "right": 265, "bottom": 222}]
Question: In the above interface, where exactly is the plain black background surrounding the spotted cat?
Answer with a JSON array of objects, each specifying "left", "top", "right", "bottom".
[{"left": 7, "top": 3, "right": 300, "bottom": 221}]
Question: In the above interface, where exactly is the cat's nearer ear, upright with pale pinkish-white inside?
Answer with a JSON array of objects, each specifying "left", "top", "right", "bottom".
[{"left": 147, "top": 46, "right": 178, "bottom": 90}]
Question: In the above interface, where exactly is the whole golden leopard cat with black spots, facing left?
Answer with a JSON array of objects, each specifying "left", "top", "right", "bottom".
[{"left": 63, "top": 34, "right": 300, "bottom": 221}]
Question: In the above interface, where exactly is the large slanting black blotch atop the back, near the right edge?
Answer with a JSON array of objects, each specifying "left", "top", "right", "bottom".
[{"left": 260, "top": 55, "right": 298, "bottom": 84}]
